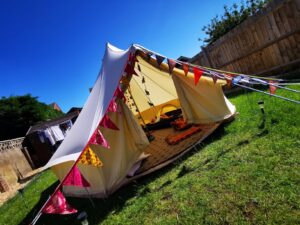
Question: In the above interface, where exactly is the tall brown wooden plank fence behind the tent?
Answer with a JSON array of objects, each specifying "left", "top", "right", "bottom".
[{"left": 189, "top": 0, "right": 300, "bottom": 75}]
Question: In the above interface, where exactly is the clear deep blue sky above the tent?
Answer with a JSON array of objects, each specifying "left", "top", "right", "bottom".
[{"left": 0, "top": 0, "right": 239, "bottom": 112}]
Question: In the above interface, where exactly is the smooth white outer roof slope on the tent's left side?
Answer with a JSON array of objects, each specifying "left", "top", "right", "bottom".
[{"left": 44, "top": 43, "right": 131, "bottom": 168}]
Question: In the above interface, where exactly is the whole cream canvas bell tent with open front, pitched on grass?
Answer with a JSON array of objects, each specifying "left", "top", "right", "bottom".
[{"left": 45, "top": 44, "right": 236, "bottom": 197}]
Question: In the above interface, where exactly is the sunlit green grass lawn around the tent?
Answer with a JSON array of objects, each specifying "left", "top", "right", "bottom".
[{"left": 0, "top": 87, "right": 300, "bottom": 225}]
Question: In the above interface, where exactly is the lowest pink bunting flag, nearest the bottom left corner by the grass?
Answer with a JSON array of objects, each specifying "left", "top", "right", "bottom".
[{"left": 42, "top": 190, "right": 77, "bottom": 215}]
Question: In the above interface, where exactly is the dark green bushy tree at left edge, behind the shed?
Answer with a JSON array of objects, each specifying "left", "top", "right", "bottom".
[{"left": 0, "top": 94, "right": 63, "bottom": 140}]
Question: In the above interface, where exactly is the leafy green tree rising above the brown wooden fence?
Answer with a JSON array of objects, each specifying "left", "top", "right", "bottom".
[{"left": 202, "top": 0, "right": 270, "bottom": 44}]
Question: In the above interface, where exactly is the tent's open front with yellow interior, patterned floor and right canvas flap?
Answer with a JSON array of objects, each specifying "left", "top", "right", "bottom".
[{"left": 117, "top": 52, "right": 233, "bottom": 181}]
